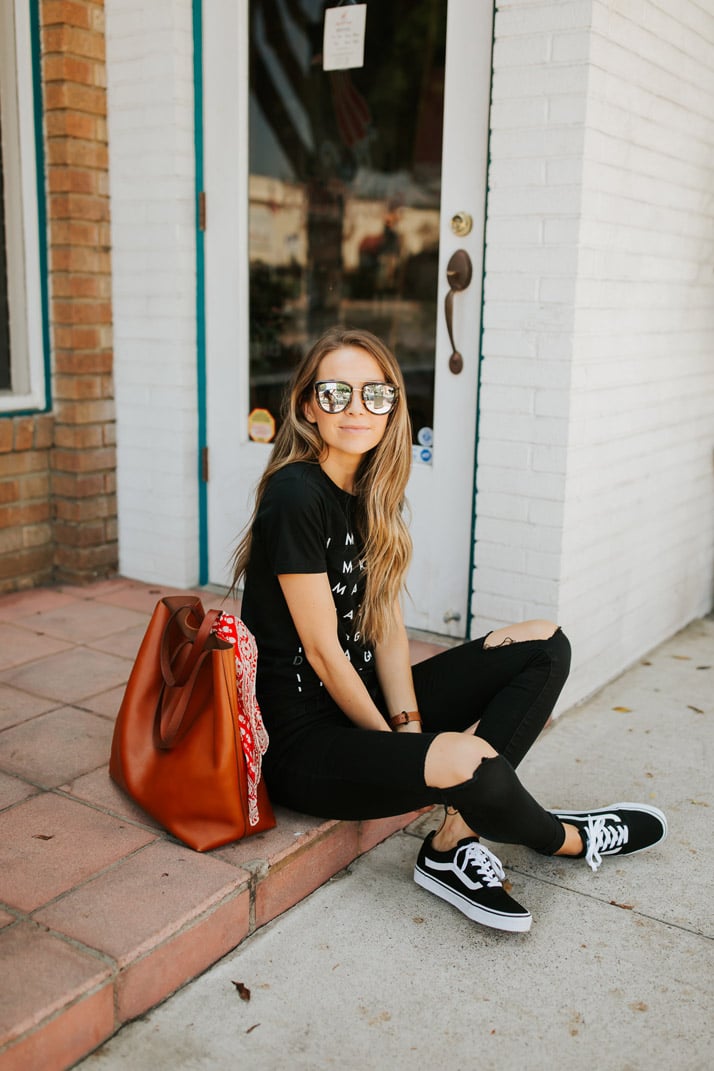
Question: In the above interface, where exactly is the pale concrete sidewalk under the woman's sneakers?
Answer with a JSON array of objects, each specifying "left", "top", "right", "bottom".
[{"left": 80, "top": 619, "right": 714, "bottom": 1071}]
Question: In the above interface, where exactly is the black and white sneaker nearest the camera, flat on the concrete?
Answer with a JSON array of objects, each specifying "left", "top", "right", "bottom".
[{"left": 414, "top": 833, "right": 533, "bottom": 933}]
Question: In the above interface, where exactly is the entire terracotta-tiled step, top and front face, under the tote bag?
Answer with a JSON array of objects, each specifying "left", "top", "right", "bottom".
[{"left": 0, "top": 577, "right": 447, "bottom": 1071}]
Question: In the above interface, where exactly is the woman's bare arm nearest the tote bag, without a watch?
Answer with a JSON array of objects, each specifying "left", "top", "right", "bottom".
[{"left": 278, "top": 573, "right": 391, "bottom": 733}]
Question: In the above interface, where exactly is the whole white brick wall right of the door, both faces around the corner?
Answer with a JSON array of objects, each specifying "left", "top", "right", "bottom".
[{"left": 474, "top": 0, "right": 714, "bottom": 706}]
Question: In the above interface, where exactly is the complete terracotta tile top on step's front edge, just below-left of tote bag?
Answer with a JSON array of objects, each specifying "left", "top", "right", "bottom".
[{"left": 34, "top": 841, "right": 249, "bottom": 967}]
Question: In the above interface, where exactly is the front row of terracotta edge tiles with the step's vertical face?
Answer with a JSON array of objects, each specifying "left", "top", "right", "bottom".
[{"left": 0, "top": 796, "right": 420, "bottom": 1071}]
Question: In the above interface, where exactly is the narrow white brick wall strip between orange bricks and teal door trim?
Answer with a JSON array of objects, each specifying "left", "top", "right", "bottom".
[{"left": 106, "top": 0, "right": 198, "bottom": 586}]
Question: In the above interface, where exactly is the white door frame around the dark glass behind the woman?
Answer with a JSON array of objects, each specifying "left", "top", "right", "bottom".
[{"left": 203, "top": 0, "right": 492, "bottom": 637}]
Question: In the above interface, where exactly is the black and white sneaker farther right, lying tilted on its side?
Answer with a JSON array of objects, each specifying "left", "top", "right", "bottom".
[{"left": 553, "top": 803, "right": 667, "bottom": 872}]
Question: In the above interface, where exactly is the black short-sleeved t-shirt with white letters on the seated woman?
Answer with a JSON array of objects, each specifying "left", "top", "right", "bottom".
[{"left": 241, "top": 462, "right": 375, "bottom": 711}]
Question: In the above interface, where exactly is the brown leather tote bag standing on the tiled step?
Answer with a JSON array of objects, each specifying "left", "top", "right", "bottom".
[{"left": 109, "top": 595, "right": 275, "bottom": 851}]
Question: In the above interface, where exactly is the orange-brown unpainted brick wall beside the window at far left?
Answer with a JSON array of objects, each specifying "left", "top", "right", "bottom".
[{"left": 0, "top": 0, "right": 118, "bottom": 590}]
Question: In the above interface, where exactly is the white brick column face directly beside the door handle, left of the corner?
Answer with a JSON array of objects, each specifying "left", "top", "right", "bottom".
[{"left": 472, "top": 0, "right": 591, "bottom": 635}]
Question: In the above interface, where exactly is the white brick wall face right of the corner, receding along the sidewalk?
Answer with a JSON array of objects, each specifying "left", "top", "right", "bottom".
[{"left": 559, "top": 0, "right": 714, "bottom": 697}]
